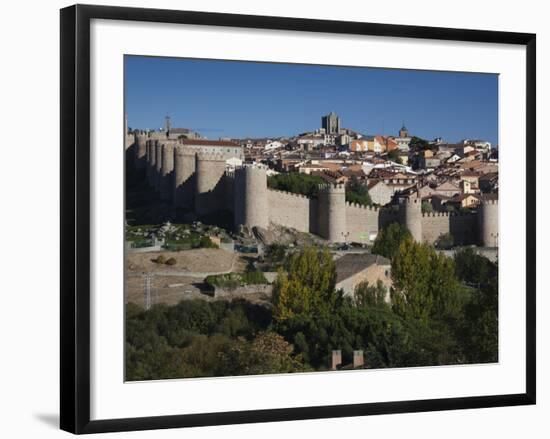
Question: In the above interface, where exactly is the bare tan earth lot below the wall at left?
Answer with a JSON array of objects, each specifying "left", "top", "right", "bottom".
[{"left": 126, "top": 249, "right": 246, "bottom": 306}]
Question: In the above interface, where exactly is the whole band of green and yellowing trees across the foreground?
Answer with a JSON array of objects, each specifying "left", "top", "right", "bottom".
[{"left": 126, "top": 224, "right": 498, "bottom": 380}]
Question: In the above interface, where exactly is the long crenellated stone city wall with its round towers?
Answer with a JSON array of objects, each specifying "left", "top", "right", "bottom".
[{"left": 132, "top": 134, "right": 498, "bottom": 247}]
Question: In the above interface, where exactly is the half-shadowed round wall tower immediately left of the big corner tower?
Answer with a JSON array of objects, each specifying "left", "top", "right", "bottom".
[{"left": 195, "top": 153, "right": 225, "bottom": 215}]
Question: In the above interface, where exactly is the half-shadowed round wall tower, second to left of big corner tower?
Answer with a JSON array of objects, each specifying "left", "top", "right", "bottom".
[{"left": 172, "top": 145, "right": 196, "bottom": 208}]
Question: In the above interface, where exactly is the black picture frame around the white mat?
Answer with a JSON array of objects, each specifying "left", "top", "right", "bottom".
[{"left": 60, "top": 5, "right": 536, "bottom": 434}]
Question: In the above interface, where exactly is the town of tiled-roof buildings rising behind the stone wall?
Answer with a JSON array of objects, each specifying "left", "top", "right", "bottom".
[{"left": 126, "top": 113, "right": 498, "bottom": 219}]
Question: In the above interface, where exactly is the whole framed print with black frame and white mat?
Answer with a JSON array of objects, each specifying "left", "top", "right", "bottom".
[{"left": 61, "top": 5, "right": 536, "bottom": 433}]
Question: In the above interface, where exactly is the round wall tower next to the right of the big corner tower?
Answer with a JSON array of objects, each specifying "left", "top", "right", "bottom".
[{"left": 319, "top": 184, "right": 347, "bottom": 242}]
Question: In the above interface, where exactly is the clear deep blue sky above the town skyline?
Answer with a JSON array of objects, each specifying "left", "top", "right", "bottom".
[{"left": 125, "top": 56, "right": 498, "bottom": 145}]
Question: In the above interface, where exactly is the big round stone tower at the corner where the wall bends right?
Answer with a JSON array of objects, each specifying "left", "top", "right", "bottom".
[{"left": 235, "top": 165, "right": 269, "bottom": 229}]
